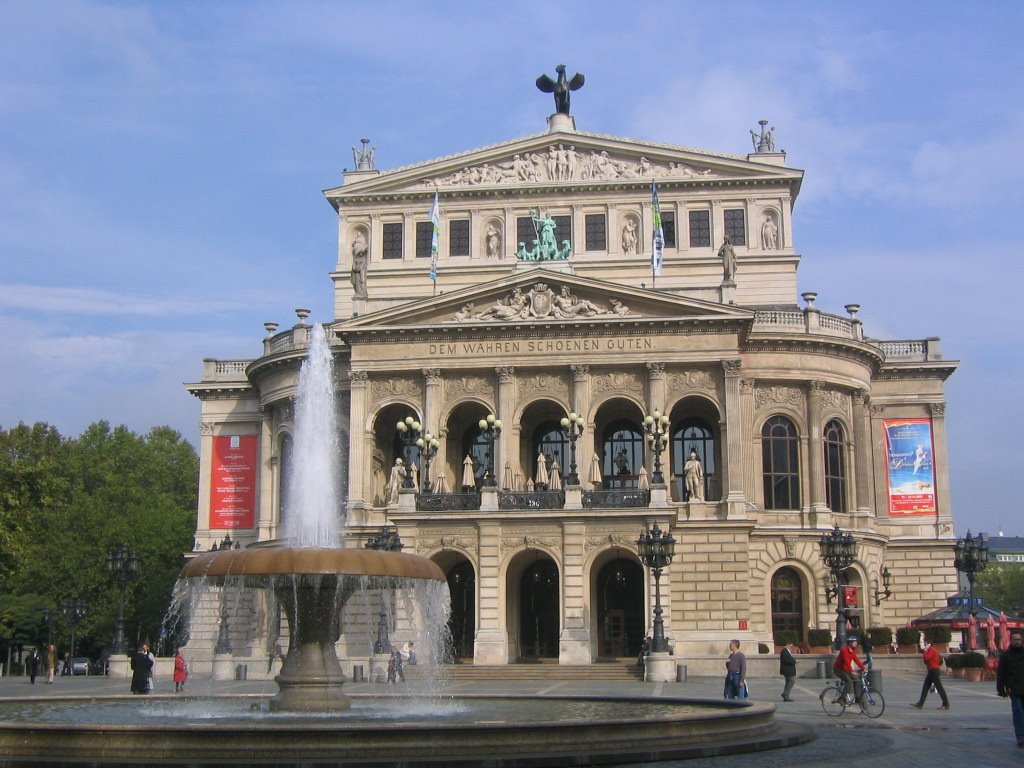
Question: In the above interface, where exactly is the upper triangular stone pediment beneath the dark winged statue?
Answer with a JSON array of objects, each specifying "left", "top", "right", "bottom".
[{"left": 325, "top": 132, "right": 803, "bottom": 200}]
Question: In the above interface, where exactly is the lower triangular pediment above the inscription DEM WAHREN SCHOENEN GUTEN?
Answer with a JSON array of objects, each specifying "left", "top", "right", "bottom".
[{"left": 333, "top": 266, "right": 754, "bottom": 337}]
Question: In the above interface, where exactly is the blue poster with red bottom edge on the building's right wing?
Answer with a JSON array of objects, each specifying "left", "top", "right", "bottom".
[{"left": 884, "top": 419, "right": 936, "bottom": 517}]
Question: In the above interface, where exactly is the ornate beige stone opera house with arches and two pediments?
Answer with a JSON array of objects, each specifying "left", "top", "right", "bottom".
[{"left": 187, "top": 99, "right": 956, "bottom": 665}]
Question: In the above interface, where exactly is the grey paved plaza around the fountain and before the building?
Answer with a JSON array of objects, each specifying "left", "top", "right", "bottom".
[{"left": 0, "top": 672, "right": 1024, "bottom": 768}]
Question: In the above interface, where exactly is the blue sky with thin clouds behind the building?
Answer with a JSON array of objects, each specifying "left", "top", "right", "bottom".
[{"left": 0, "top": 0, "right": 1024, "bottom": 535}]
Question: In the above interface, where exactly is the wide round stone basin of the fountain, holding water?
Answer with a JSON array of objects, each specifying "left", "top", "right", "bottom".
[{"left": 0, "top": 695, "right": 811, "bottom": 767}]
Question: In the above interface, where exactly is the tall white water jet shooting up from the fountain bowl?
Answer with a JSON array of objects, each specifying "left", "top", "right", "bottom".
[{"left": 284, "top": 324, "right": 344, "bottom": 547}]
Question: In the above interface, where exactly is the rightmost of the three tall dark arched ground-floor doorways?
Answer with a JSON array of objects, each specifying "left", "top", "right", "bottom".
[{"left": 595, "top": 557, "right": 644, "bottom": 658}]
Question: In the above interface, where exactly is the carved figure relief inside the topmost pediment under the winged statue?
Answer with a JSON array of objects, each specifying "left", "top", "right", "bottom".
[{"left": 422, "top": 143, "right": 714, "bottom": 186}]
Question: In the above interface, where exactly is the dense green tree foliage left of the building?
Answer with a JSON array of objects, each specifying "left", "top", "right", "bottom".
[{"left": 0, "top": 422, "right": 199, "bottom": 654}]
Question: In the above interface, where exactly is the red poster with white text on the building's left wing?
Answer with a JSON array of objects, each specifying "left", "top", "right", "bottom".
[{"left": 210, "top": 435, "right": 258, "bottom": 528}]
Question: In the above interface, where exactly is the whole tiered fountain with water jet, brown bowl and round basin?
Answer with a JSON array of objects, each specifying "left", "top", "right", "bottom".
[{"left": 0, "top": 326, "right": 810, "bottom": 767}]
